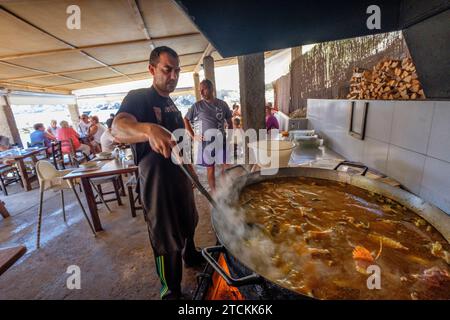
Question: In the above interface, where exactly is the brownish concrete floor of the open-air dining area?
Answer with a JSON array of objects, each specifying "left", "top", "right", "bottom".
[{"left": 0, "top": 166, "right": 215, "bottom": 299}]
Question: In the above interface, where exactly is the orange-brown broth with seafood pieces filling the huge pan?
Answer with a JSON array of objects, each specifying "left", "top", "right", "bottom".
[{"left": 239, "top": 178, "right": 450, "bottom": 299}]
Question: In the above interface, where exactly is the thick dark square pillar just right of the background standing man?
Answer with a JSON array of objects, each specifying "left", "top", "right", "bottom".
[{"left": 238, "top": 53, "right": 266, "bottom": 130}]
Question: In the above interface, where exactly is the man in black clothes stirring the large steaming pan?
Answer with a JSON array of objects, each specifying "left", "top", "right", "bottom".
[{"left": 113, "top": 46, "right": 204, "bottom": 299}]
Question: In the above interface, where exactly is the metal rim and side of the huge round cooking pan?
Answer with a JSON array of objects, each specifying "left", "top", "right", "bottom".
[{"left": 202, "top": 167, "right": 450, "bottom": 299}]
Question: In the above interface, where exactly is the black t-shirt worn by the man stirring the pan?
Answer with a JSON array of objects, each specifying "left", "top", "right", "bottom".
[{"left": 117, "top": 86, "right": 184, "bottom": 164}]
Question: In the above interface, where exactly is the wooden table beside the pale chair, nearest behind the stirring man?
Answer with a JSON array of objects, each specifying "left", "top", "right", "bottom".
[{"left": 63, "top": 160, "right": 138, "bottom": 231}]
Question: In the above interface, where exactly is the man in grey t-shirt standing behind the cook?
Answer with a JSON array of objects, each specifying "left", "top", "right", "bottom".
[{"left": 184, "top": 79, "right": 233, "bottom": 192}]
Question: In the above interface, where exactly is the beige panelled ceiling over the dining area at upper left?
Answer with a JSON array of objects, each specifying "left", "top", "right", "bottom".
[{"left": 0, "top": 0, "right": 243, "bottom": 93}]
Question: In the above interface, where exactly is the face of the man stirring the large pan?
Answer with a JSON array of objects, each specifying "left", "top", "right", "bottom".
[{"left": 149, "top": 52, "right": 180, "bottom": 95}]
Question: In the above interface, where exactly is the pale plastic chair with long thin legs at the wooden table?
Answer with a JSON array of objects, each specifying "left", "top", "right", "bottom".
[{"left": 36, "top": 160, "right": 96, "bottom": 248}]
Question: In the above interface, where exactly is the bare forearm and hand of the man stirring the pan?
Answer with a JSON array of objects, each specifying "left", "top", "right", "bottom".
[{"left": 112, "top": 112, "right": 176, "bottom": 158}]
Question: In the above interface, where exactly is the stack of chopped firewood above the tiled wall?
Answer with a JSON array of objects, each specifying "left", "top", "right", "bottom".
[{"left": 347, "top": 58, "right": 425, "bottom": 100}]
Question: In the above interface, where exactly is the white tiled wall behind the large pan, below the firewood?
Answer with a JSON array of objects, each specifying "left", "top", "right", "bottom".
[{"left": 308, "top": 99, "right": 450, "bottom": 214}]
